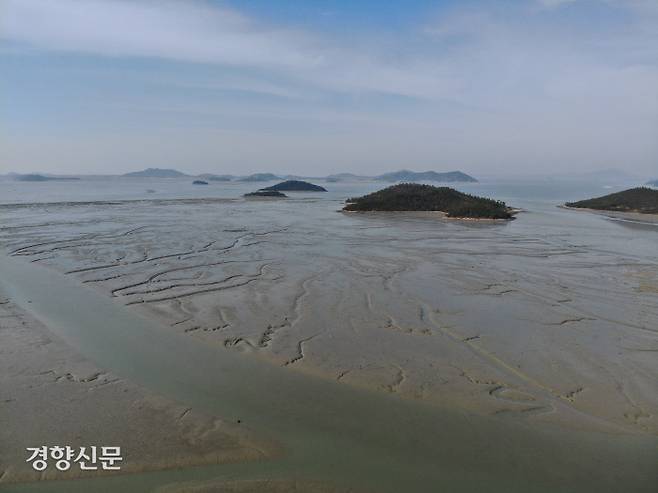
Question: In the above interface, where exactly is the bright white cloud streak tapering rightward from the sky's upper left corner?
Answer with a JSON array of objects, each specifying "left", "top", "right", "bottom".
[{"left": 0, "top": 0, "right": 316, "bottom": 67}]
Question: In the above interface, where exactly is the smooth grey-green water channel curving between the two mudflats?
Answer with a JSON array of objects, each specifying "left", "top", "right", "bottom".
[{"left": 0, "top": 254, "right": 657, "bottom": 492}]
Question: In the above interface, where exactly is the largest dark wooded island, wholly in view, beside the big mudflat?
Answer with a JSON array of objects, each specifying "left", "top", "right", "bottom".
[{"left": 343, "top": 183, "right": 512, "bottom": 219}]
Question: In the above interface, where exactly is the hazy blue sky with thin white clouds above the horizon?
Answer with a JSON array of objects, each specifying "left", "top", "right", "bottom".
[{"left": 0, "top": 0, "right": 658, "bottom": 176}]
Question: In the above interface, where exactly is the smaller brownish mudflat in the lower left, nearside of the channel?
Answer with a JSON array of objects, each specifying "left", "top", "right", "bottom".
[{"left": 0, "top": 299, "right": 278, "bottom": 484}]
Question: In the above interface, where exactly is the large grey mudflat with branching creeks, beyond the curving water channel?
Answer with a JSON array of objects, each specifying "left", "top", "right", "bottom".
[{"left": 0, "top": 194, "right": 658, "bottom": 434}]
